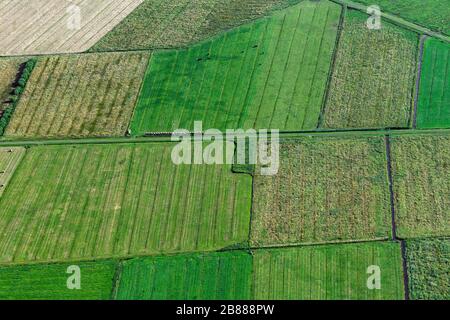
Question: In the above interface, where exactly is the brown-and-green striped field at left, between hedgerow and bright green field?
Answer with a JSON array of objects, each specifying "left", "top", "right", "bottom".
[{"left": 6, "top": 53, "right": 149, "bottom": 137}]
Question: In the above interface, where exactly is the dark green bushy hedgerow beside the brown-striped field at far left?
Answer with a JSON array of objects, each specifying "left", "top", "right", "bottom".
[{"left": 0, "top": 58, "right": 37, "bottom": 136}]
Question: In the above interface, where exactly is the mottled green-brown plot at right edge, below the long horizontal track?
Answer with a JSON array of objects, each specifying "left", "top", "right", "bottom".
[{"left": 392, "top": 135, "right": 450, "bottom": 238}]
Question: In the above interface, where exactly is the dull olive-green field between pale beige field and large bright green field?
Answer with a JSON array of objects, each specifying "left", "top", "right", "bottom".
[{"left": 91, "top": 0, "right": 300, "bottom": 51}]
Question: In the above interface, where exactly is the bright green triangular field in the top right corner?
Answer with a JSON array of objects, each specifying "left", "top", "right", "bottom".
[{"left": 353, "top": 0, "right": 450, "bottom": 35}]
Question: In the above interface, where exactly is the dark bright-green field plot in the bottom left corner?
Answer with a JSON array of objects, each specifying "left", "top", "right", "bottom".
[{"left": 0, "top": 261, "right": 116, "bottom": 300}]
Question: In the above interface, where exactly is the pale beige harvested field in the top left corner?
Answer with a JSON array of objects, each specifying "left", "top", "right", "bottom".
[{"left": 0, "top": 0, "right": 143, "bottom": 56}]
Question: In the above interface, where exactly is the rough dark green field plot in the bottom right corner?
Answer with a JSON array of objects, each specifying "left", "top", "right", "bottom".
[{"left": 406, "top": 238, "right": 450, "bottom": 300}]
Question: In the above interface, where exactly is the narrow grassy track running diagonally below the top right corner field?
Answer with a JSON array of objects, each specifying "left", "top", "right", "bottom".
[{"left": 329, "top": 0, "right": 450, "bottom": 42}]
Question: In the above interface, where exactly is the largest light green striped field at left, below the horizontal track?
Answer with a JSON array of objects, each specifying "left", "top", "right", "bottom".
[{"left": 0, "top": 143, "right": 252, "bottom": 263}]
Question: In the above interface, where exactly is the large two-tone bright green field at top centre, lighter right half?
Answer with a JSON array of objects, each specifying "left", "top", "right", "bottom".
[{"left": 131, "top": 1, "right": 341, "bottom": 135}]
